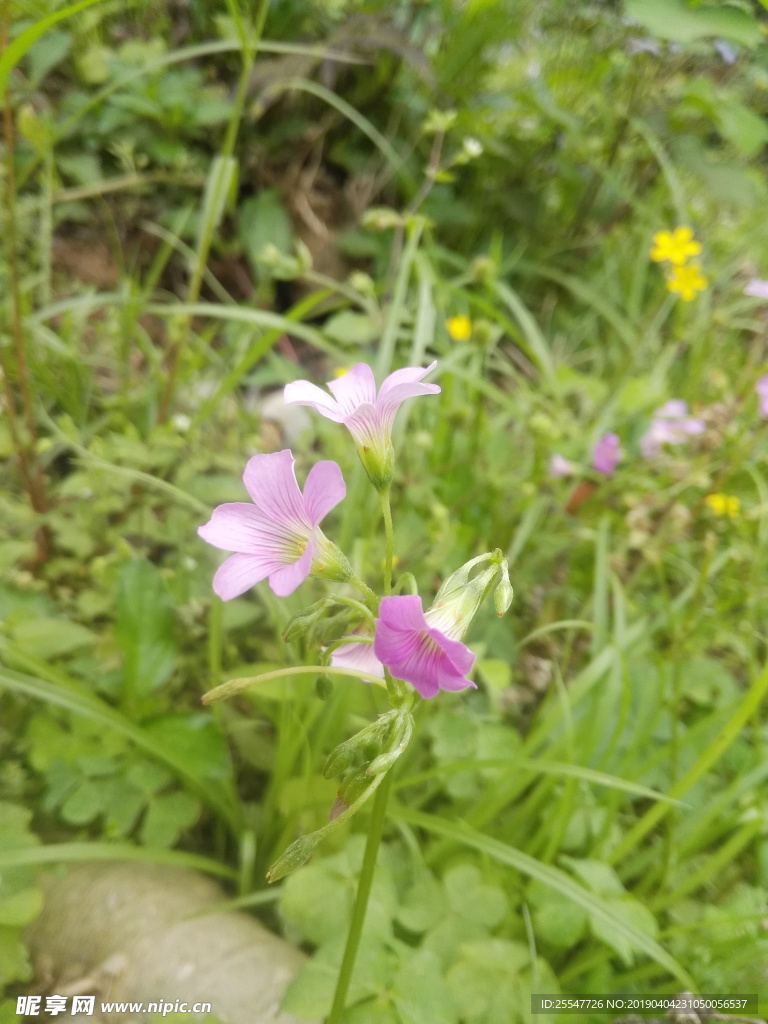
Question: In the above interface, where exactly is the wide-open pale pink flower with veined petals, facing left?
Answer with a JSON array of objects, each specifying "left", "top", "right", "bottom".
[{"left": 198, "top": 450, "right": 346, "bottom": 601}]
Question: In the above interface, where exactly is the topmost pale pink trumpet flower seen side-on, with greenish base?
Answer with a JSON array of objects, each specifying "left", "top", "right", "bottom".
[{"left": 285, "top": 362, "right": 440, "bottom": 488}]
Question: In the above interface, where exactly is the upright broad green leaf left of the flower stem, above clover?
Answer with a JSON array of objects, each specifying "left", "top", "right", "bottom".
[{"left": 115, "top": 560, "right": 176, "bottom": 706}]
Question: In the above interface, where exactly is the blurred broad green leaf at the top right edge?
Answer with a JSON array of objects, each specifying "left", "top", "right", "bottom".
[{"left": 625, "top": 0, "right": 763, "bottom": 47}]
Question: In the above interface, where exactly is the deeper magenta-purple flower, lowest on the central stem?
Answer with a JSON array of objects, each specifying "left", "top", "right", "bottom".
[{"left": 374, "top": 595, "right": 475, "bottom": 698}]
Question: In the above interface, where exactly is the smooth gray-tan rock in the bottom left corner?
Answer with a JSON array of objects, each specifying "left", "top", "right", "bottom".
[{"left": 27, "top": 863, "right": 315, "bottom": 1024}]
